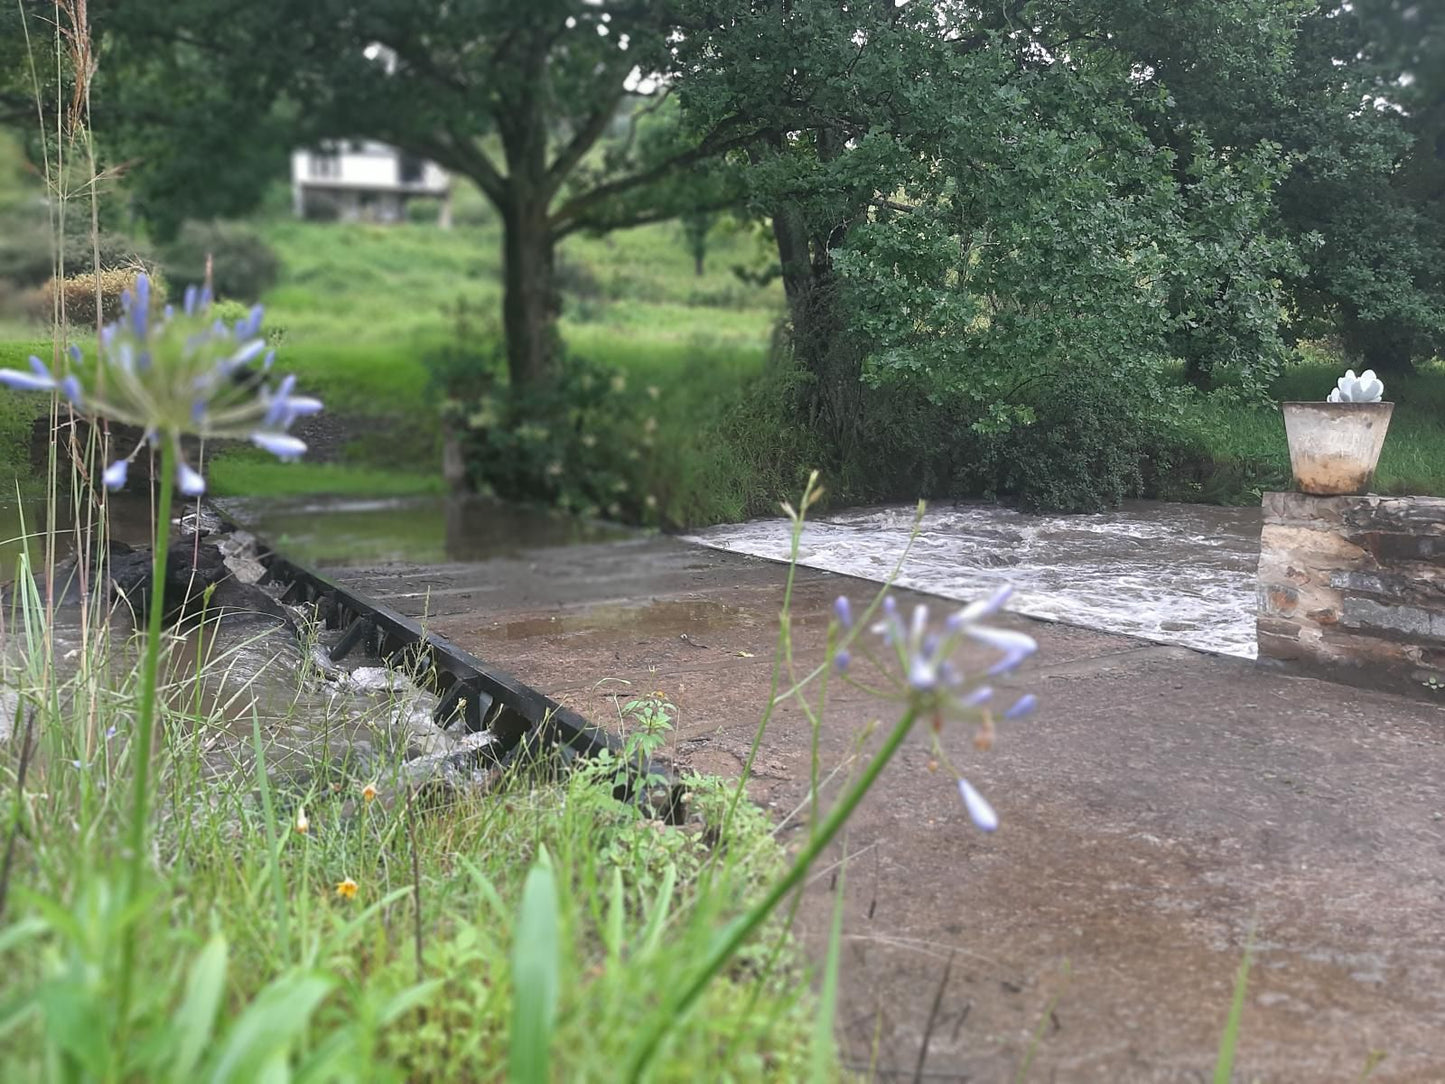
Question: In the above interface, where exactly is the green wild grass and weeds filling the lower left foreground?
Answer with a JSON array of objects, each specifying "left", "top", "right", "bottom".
[{"left": 0, "top": 555, "right": 832, "bottom": 1081}]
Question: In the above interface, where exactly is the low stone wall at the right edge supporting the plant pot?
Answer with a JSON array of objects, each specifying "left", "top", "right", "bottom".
[{"left": 1259, "top": 493, "right": 1445, "bottom": 695}]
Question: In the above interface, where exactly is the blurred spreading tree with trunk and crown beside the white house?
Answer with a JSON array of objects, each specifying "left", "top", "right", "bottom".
[{"left": 92, "top": 0, "right": 756, "bottom": 386}]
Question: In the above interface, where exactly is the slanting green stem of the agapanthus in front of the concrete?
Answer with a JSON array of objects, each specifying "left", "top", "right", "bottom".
[{"left": 627, "top": 707, "right": 918, "bottom": 1084}]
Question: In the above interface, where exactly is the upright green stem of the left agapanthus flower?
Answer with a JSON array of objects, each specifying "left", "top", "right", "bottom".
[{"left": 120, "top": 436, "right": 175, "bottom": 1028}]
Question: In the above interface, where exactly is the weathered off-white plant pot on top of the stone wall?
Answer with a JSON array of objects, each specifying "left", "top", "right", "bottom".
[{"left": 1280, "top": 403, "right": 1394, "bottom": 497}]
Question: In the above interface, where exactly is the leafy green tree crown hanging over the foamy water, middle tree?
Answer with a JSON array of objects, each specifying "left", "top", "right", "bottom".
[{"left": 675, "top": 0, "right": 1293, "bottom": 448}]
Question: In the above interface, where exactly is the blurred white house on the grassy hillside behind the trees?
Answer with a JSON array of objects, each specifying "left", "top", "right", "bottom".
[{"left": 290, "top": 140, "right": 451, "bottom": 228}]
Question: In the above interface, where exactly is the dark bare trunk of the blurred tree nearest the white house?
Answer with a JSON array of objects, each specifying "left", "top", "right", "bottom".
[{"left": 501, "top": 198, "right": 561, "bottom": 389}]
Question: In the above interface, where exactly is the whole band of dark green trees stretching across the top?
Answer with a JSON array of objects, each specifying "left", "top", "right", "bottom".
[{"left": 9, "top": 0, "right": 1445, "bottom": 507}]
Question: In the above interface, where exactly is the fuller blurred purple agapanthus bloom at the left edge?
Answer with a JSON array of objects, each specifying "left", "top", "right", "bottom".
[{"left": 0, "top": 275, "right": 321, "bottom": 496}]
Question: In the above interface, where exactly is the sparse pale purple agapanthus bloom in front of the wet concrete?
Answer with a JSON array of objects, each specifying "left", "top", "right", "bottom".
[{"left": 834, "top": 587, "right": 1039, "bottom": 831}]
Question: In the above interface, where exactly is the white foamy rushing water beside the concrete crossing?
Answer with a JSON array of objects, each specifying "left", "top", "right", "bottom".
[{"left": 691, "top": 502, "right": 1260, "bottom": 659}]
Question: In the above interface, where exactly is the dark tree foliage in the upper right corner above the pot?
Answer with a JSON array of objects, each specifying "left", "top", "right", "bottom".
[{"left": 1061, "top": 0, "right": 1445, "bottom": 371}]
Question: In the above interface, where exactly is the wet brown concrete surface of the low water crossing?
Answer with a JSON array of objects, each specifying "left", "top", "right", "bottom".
[{"left": 319, "top": 538, "right": 1445, "bottom": 1083}]
